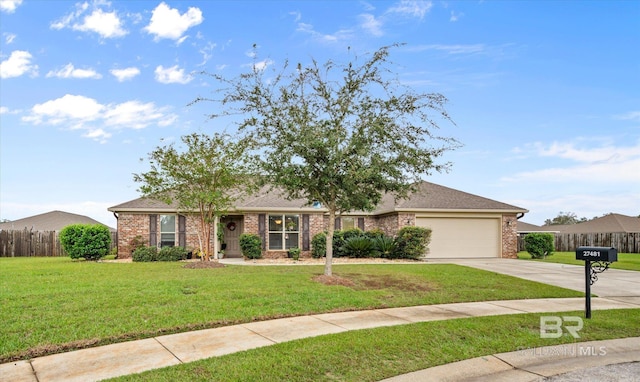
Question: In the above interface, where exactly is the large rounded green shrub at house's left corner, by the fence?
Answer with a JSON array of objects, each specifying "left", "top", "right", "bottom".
[{"left": 59, "top": 224, "right": 111, "bottom": 260}]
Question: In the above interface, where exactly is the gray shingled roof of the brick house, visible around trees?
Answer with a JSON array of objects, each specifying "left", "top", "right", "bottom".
[{"left": 109, "top": 182, "right": 528, "bottom": 215}]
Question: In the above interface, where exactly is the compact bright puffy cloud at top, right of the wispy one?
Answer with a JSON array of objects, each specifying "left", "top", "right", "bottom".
[{"left": 144, "top": 2, "right": 203, "bottom": 43}]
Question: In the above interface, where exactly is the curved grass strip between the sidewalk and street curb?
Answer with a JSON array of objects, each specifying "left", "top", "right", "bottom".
[{"left": 112, "top": 309, "right": 640, "bottom": 382}]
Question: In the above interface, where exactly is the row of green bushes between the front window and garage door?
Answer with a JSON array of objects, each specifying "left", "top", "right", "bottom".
[{"left": 311, "top": 226, "right": 431, "bottom": 260}]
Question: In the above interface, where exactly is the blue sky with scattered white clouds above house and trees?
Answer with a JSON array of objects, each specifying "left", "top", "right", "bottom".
[{"left": 0, "top": 0, "right": 640, "bottom": 227}]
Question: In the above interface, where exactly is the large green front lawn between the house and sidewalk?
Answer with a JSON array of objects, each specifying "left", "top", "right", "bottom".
[{"left": 0, "top": 258, "right": 583, "bottom": 363}]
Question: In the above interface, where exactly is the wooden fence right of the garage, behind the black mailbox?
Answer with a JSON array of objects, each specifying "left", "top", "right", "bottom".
[{"left": 518, "top": 232, "right": 640, "bottom": 253}]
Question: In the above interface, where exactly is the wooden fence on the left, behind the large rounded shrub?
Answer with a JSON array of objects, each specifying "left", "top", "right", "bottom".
[{"left": 0, "top": 229, "right": 118, "bottom": 257}]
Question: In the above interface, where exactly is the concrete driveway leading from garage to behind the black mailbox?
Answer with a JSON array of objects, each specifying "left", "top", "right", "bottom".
[{"left": 428, "top": 255, "right": 640, "bottom": 303}]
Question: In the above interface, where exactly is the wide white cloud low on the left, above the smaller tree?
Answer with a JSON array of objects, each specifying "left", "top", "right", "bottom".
[{"left": 22, "top": 94, "right": 177, "bottom": 142}]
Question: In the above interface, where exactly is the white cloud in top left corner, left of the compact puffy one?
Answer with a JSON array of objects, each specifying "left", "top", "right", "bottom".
[{"left": 51, "top": 1, "right": 129, "bottom": 38}]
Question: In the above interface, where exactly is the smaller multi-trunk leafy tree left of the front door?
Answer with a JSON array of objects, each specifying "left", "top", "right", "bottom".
[{"left": 134, "top": 133, "right": 249, "bottom": 260}]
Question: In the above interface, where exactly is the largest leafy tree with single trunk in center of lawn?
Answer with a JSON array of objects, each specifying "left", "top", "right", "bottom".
[{"left": 195, "top": 47, "right": 458, "bottom": 276}]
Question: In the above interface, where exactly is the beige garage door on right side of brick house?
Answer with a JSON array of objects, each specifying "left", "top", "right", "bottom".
[{"left": 416, "top": 218, "right": 501, "bottom": 259}]
